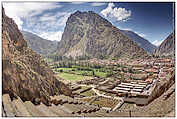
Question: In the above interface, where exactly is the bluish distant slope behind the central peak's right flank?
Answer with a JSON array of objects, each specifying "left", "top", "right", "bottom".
[{"left": 121, "top": 30, "right": 157, "bottom": 53}]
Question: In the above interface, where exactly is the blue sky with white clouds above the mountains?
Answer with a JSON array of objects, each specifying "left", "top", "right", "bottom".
[{"left": 3, "top": 2, "right": 174, "bottom": 45}]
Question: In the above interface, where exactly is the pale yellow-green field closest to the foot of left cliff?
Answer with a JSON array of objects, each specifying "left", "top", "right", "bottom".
[{"left": 58, "top": 73, "right": 89, "bottom": 81}]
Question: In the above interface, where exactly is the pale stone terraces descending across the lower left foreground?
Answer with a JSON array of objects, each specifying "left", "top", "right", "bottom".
[{"left": 2, "top": 94, "right": 111, "bottom": 117}]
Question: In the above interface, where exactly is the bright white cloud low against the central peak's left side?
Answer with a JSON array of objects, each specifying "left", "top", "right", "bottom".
[{"left": 39, "top": 31, "right": 63, "bottom": 41}]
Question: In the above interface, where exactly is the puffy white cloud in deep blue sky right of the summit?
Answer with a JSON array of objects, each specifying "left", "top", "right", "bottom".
[{"left": 101, "top": 3, "right": 131, "bottom": 21}]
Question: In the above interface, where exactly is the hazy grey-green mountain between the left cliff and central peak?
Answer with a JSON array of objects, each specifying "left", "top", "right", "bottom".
[{"left": 21, "top": 31, "right": 58, "bottom": 55}]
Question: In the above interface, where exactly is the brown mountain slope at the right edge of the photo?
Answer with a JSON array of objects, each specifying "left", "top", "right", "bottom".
[{"left": 154, "top": 32, "right": 175, "bottom": 57}]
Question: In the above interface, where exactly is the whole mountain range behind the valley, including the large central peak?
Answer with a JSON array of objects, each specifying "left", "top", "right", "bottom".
[{"left": 22, "top": 11, "right": 175, "bottom": 58}]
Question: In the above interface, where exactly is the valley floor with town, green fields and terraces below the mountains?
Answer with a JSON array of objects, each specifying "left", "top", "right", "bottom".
[{"left": 3, "top": 58, "right": 175, "bottom": 117}]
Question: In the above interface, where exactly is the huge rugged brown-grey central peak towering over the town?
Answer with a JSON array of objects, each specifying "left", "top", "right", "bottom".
[{"left": 57, "top": 11, "right": 147, "bottom": 58}]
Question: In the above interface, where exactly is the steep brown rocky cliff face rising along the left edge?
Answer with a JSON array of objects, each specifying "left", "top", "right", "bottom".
[{"left": 2, "top": 9, "right": 72, "bottom": 105}]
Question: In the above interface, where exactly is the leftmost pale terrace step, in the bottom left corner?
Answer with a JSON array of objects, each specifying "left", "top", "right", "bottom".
[{"left": 2, "top": 94, "right": 16, "bottom": 117}]
